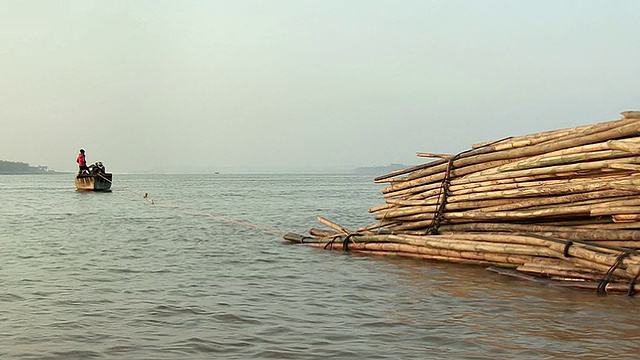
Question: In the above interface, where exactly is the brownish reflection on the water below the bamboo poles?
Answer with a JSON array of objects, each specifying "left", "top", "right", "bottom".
[{"left": 376, "top": 260, "right": 640, "bottom": 358}]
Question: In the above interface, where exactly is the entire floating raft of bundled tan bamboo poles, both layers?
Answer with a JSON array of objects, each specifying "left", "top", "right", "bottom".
[{"left": 284, "top": 111, "right": 640, "bottom": 295}]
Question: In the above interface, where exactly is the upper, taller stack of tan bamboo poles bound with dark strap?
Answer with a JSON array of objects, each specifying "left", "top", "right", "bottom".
[{"left": 362, "top": 112, "right": 640, "bottom": 238}]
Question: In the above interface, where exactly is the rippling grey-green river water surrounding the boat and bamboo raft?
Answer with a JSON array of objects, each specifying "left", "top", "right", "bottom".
[{"left": 0, "top": 174, "right": 640, "bottom": 359}]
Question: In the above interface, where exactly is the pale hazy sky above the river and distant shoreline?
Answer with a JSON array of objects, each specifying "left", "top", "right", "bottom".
[{"left": 0, "top": 0, "right": 640, "bottom": 172}]
